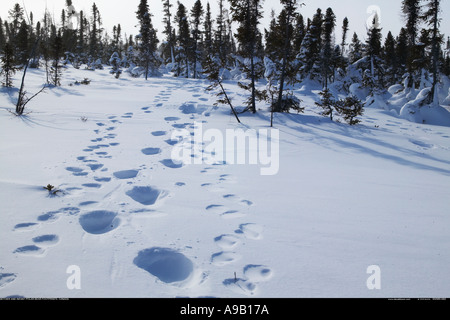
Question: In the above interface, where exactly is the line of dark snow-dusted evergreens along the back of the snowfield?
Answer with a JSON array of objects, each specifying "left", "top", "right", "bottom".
[{"left": 0, "top": 0, "right": 450, "bottom": 112}]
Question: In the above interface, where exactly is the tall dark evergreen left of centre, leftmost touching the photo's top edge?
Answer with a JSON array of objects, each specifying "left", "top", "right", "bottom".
[{"left": 136, "top": 0, "right": 159, "bottom": 80}]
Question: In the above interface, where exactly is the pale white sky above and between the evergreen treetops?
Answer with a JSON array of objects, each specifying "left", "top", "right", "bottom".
[{"left": 0, "top": 0, "right": 450, "bottom": 42}]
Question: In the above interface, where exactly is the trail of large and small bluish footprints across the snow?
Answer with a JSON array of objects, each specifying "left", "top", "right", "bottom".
[{"left": 5, "top": 89, "right": 272, "bottom": 295}]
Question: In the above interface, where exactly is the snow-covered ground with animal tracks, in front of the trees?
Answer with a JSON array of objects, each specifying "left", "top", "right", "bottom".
[{"left": 0, "top": 68, "right": 450, "bottom": 298}]
